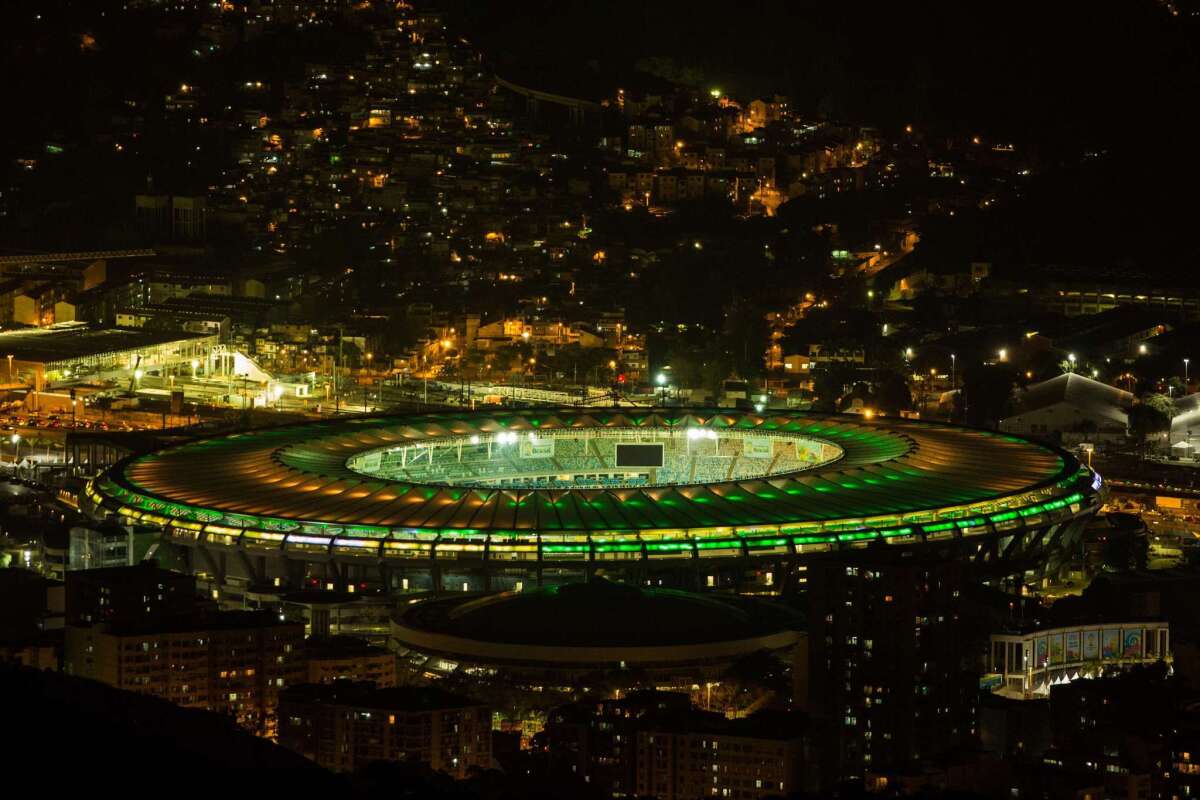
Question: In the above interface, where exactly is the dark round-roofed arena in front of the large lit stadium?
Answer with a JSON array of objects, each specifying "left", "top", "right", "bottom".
[{"left": 391, "top": 578, "right": 804, "bottom": 691}]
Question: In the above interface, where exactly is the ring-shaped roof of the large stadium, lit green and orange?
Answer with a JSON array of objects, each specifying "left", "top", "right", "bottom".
[{"left": 88, "top": 409, "right": 1098, "bottom": 541}]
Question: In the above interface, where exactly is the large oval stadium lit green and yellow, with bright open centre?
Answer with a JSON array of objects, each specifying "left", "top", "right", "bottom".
[{"left": 84, "top": 408, "right": 1100, "bottom": 596}]
